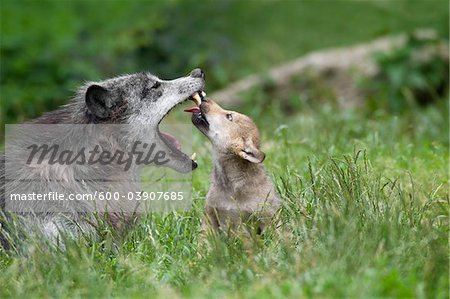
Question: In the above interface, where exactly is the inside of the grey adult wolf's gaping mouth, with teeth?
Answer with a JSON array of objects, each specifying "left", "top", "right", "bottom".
[{"left": 157, "top": 90, "right": 206, "bottom": 169}]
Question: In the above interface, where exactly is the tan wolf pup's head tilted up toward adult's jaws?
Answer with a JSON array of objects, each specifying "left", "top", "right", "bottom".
[{"left": 186, "top": 97, "right": 265, "bottom": 163}]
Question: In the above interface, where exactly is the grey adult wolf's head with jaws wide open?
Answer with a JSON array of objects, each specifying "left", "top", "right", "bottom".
[{"left": 78, "top": 69, "right": 205, "bottom": 172}]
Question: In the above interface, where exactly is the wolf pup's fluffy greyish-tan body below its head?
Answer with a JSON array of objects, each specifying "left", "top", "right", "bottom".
[{"left": 204, "top": 154, "right": 280, "bottom": 233}]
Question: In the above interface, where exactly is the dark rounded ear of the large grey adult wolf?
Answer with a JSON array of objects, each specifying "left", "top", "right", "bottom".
[{"left": 85, "top": 84, "right": 114, "bottom": 118}]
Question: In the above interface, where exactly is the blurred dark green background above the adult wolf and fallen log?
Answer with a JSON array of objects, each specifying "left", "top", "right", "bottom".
[{"left": 0, "top": 0, "right": 448, "bottom": 127}]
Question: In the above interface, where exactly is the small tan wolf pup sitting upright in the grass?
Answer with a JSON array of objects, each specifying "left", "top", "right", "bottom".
[{"left": 185, "top": 93, "right": 280, "bottom": 233}]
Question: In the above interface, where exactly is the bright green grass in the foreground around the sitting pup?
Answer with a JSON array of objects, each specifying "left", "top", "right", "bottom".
[{"left": 0, "top": 101, "right": 449, "bottom": 298}]
